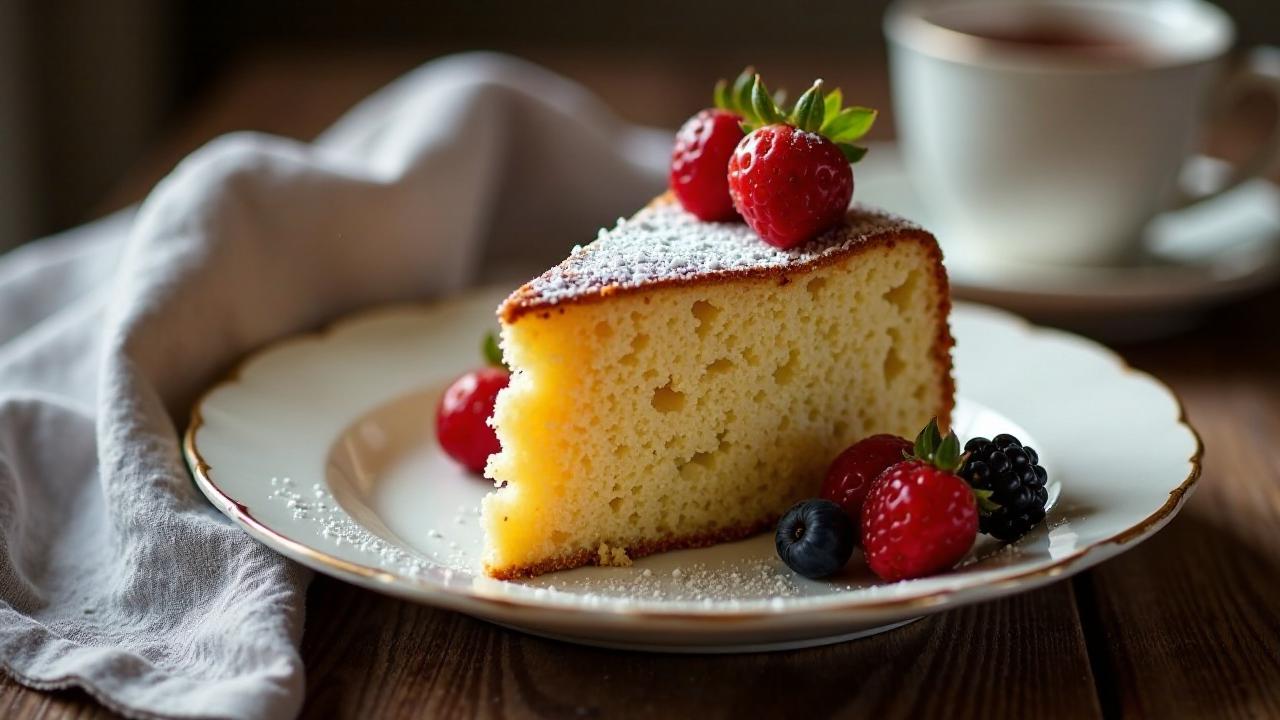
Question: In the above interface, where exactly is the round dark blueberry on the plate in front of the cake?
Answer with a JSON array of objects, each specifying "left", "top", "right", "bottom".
[{"left": 773, "top": 500, "right": 854, "bottom": 578}]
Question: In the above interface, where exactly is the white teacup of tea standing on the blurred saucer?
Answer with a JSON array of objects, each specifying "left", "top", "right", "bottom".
[{"left": 884, "top": 0, "right": 1280, "bottom": 264}]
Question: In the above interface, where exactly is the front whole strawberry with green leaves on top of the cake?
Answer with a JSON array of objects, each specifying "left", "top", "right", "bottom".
[{"left": 728, "top": 76, "right": 876, "bottom": 250}]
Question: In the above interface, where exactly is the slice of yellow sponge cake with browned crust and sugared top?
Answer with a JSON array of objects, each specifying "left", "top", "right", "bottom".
[{"left": 481, "top": 196, "right": 954, "bottom": 578}]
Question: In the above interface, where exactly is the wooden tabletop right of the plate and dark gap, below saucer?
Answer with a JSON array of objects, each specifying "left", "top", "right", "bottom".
[{"left": 1078, "top": 292, "right": 1280, "bottom": 717}]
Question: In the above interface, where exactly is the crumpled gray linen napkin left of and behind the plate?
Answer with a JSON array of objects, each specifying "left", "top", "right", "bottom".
[{"left": 0, "top": 54, "right": 669, "bottom": 719}]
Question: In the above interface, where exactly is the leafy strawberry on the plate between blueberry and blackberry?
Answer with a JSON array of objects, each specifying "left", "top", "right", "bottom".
[{"left": 861, "top": 420, "right": 984, "bottom": 582}]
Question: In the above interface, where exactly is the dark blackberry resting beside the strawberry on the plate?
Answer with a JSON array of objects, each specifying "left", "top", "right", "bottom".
[{"left": 960, "top": 434, "right": 1048, "bottom": 542}]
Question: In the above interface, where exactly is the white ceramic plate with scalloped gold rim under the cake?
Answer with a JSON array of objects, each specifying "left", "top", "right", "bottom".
[{"left": 186, "top": 284, "right": 1201, "bottom": 652}]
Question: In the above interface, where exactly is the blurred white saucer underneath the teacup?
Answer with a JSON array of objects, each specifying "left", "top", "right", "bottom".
[{"left": 855, "top": 143, "right": 1280, "bottom": 341}]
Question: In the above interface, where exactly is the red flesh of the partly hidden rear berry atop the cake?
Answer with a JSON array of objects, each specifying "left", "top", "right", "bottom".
[{"left": 668, "top": 109, "right": 744, "bottom": 222}]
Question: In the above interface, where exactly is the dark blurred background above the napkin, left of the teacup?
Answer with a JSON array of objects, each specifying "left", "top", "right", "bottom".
[{"left": 0, "top": 0, "right": 1280, "bottom": 249}]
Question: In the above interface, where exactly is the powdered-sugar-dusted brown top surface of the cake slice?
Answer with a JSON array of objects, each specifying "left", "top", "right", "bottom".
[{"left": 508, "top": 201, "right": 919, "bottom": 305}]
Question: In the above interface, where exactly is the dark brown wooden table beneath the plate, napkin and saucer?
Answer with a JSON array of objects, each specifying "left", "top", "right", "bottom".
[{"left": 0, "top": 54, "right": 1280, "bottom": 717}]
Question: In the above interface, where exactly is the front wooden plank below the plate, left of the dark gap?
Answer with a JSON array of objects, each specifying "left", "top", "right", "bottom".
[{"left": 294, "top": 578, "right": 1098, "bottom": 720}]
